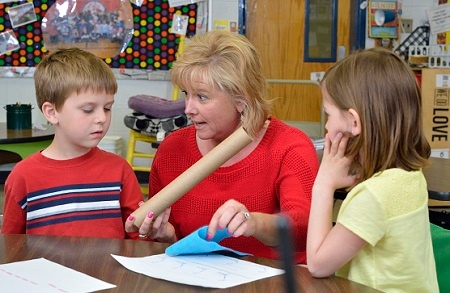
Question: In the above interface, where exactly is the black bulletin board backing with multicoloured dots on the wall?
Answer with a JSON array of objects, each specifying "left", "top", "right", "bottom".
[{"left": 0, "top": 0, "right": 197, "bottom": 70}]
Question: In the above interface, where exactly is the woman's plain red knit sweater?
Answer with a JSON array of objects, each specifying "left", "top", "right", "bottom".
[{"left": 150, "top": 118, "right": 319, "bottom": 263}]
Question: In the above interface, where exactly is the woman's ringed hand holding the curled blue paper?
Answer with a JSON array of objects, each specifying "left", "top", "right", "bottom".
[{"left": 206, "top": 199, "right": 256, "bottom": 240}]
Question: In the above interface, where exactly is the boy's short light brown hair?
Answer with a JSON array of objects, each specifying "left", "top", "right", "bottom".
[{"left": 34, "top": 48, "right": 117, "bottom": 110}]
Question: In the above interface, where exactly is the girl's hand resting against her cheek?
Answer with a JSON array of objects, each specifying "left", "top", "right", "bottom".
[{"left": 314, "top": 133, "right": 356, "bottom": 190}]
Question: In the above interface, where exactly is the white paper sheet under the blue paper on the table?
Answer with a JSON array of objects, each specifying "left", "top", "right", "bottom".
[{"left": 111, "top": 253, "right": 284, "bottom": 289}]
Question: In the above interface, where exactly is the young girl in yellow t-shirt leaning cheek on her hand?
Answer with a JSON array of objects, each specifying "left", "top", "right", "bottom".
[{"left": 307, "top": 48, "right": 439, "bottom": 292}]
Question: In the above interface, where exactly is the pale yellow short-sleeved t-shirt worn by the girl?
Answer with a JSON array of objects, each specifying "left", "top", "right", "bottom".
[{"left": 336, "top": 169, "right": 439, "bottom": 293}]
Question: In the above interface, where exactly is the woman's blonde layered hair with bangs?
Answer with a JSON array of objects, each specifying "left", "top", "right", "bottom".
[{"left": 171, "top": 30, "right": 272, "bottom": 137}]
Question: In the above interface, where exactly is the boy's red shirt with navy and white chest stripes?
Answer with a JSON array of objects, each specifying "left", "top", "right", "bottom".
[{"left": 1, "top": 148, "right": 143, "bottom": 238}]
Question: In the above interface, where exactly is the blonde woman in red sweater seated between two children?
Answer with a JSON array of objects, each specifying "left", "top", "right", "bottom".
[{"left": 127, "top": 31, "right": 319, "bottom": 263}]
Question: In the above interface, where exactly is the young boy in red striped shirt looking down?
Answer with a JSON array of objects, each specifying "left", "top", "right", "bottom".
[{"left": 1, "top": 48, "right": 143, "bottom": 238}]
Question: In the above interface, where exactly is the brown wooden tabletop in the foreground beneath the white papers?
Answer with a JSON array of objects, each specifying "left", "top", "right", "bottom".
[{"left": 0, "top": 234, "right": 378, "bottom": 293}]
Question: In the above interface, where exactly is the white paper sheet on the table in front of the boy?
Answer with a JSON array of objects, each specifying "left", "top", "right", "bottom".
[{"left": 0, "top": 258, "right": 116, "bottom": 293}]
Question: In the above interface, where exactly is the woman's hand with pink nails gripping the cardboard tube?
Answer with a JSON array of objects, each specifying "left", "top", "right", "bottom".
[{"left": 125, "top": 208, "right": 177, "bottom": 243}]
